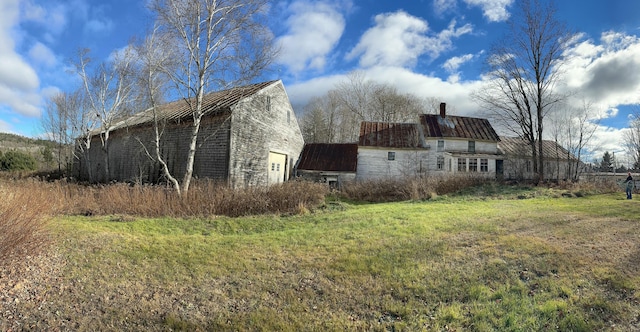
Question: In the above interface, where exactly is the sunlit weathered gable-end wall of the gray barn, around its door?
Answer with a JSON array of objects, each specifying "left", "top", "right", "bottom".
[{"left": 229, "top": 82, "right": 304, "bottom": 188}]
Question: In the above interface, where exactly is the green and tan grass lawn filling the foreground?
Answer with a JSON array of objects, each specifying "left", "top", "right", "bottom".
[{"left": 11, "top": 191, "right": 640, "bottom": 331}]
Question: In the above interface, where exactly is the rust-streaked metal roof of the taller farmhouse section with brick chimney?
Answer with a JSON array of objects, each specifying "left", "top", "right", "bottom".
[{"left": 420, "top": 114, "right": 500, "bottom": 142}]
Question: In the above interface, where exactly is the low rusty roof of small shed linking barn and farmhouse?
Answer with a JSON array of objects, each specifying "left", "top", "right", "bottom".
[{"left": 298, "top": 143, "right": 358, "bottom": 173}]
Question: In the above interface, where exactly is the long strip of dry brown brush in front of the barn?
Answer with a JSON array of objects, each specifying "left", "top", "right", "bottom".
[{"left": 43, "top": 181, "right": 327, "bottom": 218}]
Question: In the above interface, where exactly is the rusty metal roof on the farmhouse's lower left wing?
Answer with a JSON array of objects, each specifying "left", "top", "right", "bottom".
[{"left": 358, "top": 121, "right": 424, "bottom": 148}]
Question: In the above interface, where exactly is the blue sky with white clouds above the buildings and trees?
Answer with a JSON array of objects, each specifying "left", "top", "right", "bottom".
[{"left": 0, "top": 0, "right": 640, "bottom": 165}]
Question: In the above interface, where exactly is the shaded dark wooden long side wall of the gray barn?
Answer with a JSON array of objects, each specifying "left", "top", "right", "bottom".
[{"left": 76, "top": 113, "right": 230, "bottom": 183}]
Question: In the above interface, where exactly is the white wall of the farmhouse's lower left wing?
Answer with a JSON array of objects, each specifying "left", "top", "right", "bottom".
[{"left": 356, "top": 146, "right": 429, "bottom": 180}]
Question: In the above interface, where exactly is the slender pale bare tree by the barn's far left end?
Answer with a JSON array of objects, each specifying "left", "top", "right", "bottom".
[{"left": 75, "top": 47, "right": 135, "bottom": 181}]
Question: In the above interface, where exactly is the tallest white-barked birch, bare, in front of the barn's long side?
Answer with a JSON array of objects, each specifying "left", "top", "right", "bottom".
[{"left": 150, "top": 0, "right": 276, "bottom": 193}]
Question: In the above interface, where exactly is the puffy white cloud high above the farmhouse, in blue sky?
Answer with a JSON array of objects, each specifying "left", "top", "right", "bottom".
[{"left": 346, "top": 11, "right": 472, "bottom": 67}]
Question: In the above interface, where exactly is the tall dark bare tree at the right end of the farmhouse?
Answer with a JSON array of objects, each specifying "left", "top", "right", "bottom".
[{"left": 473, "top": 0, "right": 571, "bottom": 180}]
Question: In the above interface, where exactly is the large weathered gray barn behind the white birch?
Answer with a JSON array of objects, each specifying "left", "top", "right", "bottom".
[{"left": 75, "top": 80, "right": 304, "bottom": 188}]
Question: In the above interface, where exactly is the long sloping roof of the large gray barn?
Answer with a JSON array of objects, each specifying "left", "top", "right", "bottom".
[{"left": 104, "top": 80, "right": 278, "bottom": 130}]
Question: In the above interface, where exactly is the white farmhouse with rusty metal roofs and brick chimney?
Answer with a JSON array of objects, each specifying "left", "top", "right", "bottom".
[{"left": 356, "top": 103, "right": 503, "bottom": 180}]
